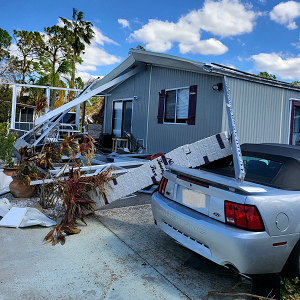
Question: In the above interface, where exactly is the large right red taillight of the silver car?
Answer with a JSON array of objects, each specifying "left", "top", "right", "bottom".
[{"left": 225, "top": 201, "right": 264, "bottom": 231}]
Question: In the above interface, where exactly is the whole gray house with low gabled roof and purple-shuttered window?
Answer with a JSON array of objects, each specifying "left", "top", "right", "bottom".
[{"left": 93, "top": 49, "right": 300, "bottom": 153}]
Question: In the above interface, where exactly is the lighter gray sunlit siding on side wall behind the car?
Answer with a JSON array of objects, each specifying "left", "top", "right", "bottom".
[{"left": 222, "top": 77, "right": 300, "bottom": 144}]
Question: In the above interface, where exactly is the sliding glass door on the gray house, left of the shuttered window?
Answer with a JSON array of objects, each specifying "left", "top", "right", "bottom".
[{"left": 112, "top": 100, "right": 132, "bottom": 137}]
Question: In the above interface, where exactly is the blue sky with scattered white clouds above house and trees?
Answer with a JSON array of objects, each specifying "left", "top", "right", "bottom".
[{"left": 0, "top": 0, "right": 300, "bottom": 82}]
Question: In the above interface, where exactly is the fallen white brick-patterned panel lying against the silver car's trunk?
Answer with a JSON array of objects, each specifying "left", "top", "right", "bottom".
[{"left": 93, "top": 131, "right": 232, "bottom": 207}]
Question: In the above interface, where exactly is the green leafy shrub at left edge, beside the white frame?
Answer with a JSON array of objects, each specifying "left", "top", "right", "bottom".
[{"left": 0, "top": 122, "right": 18, "bottom": 176}]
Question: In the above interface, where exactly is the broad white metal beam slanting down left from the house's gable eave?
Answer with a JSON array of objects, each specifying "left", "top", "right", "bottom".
[{"left": 35, "top": 66, "right": 145, "bottom": 125}]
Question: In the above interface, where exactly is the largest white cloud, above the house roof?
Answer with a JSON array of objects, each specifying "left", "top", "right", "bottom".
[{"left": 128, "top": 0, "right": 260, "bottom": 55}]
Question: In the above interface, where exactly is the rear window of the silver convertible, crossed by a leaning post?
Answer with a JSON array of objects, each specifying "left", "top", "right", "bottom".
[{"left": 201, "top": 156, "right": 282, "bottom": 183}]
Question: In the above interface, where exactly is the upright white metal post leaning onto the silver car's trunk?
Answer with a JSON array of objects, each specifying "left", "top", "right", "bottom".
[{"left": 223, "top": 76, "right": 245, "bottom": 182}]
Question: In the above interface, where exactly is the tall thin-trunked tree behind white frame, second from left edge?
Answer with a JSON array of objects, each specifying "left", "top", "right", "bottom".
[{"left": 14, "top": 30, "right": 43, "bottom": 97}]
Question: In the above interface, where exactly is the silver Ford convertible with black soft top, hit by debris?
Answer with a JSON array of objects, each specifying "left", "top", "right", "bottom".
[{"left": 152, "top": 144, "right": 300, "bottom": 277}]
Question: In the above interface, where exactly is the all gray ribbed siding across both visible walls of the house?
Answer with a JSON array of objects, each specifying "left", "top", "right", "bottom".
[{"left": 105, "top": 61, "right": 300, "bottom": 153}]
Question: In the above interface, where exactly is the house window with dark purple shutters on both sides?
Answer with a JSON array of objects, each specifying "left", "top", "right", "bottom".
[{"left": 157, "top": 85, "right": 197, "bottom": 125}]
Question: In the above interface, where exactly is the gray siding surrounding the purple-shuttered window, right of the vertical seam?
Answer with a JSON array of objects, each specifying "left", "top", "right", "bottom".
[{"left": 147, "top": 67, "right": 223, "bottom": 153}]
